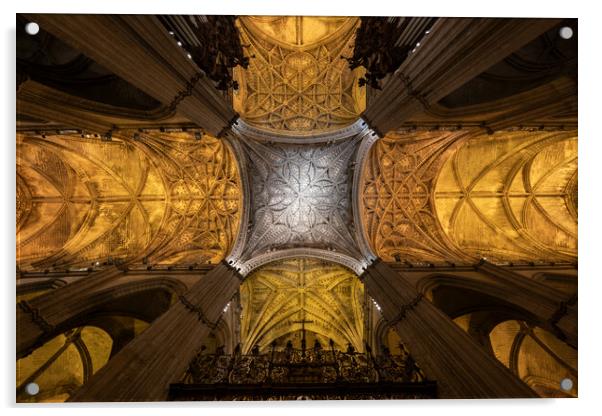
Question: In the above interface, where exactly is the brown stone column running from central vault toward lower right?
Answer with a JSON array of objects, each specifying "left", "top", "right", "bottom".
[{"left": 361, "top": 259, "right": 537, "bottom": 399}]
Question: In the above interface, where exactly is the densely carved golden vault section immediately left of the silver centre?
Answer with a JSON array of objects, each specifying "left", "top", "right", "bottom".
[{"left": 138, "top": 132, "right": 242, "bottom": 264}]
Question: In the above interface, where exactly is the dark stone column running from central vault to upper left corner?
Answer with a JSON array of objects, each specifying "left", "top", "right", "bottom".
[{"left": 26, "top": 14, "right": 236, "bottom": 136}]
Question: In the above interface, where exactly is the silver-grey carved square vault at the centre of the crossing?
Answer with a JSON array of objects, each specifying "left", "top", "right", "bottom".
[{"left": 227, "top": 120, "right": 374, "bottom": 275}]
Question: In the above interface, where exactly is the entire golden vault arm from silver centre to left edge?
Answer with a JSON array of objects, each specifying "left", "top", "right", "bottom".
[{"left": 17, "top": 132, "right": 242, "bottom": 269}]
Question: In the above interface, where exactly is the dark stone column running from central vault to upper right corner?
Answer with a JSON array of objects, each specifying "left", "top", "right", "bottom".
[{"left": 362, "top": 18, "right": 560, "bottom": 137}]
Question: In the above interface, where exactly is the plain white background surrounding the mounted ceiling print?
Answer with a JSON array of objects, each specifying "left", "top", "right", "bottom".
[{"left": 0, "top": 0, "right": 602, "bottom": 416}]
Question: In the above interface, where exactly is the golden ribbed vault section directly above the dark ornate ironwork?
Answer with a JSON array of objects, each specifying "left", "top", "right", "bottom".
[{"left": 240, "top": 258, "right": 364, "bottom": 352}]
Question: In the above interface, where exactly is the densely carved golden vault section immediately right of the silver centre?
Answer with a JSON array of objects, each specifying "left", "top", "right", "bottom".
[{"left": 359, "top": 132, "right": 463, "bottom": 262}]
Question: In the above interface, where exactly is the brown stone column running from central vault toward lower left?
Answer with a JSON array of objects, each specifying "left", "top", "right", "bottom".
[{"left": 69, "top": 263, "right": 241, "bottom": 402}]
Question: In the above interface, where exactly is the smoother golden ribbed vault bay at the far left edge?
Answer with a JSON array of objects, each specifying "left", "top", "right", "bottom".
[{"left": 17, "top": 135, "right": 165, "bottom": 268}]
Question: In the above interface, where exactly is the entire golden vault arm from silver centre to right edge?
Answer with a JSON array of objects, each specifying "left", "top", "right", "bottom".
[{"left": 359, "top": 131, "right": 577, "bottom": 262}]
